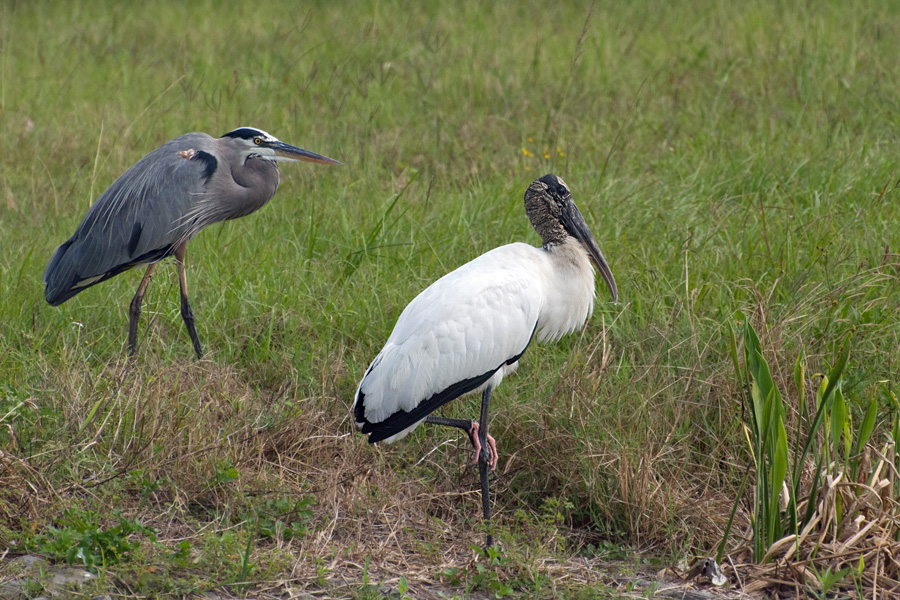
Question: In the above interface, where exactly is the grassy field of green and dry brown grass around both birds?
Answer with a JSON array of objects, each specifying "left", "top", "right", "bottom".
[{"left": 0, "top": 0, "right": 900, "bottom": 597}]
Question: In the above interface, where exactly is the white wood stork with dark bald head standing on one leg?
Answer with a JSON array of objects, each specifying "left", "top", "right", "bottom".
[{"left": 353, "top": 174, "right": 618, "bottom": 546}]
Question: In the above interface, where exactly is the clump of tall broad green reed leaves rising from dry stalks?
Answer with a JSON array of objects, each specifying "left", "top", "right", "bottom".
[{"left": 723, "top": 321, "right": 897, "bottom": 562}]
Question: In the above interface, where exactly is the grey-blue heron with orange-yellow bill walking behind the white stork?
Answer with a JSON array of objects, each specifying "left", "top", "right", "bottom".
[{"left": 44, "top": 127, "right": 341, "bottom": 357}]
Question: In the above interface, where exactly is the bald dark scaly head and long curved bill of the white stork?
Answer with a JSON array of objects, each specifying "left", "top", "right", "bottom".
[{"left": 525, "top": 173, "right": 619, "bottom": 302}]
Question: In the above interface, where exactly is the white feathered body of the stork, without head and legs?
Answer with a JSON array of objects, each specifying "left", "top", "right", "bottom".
[{"left": 354, "top": 238, "right": 594, "bottom": 442}]
